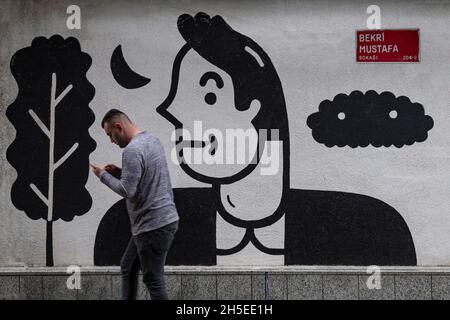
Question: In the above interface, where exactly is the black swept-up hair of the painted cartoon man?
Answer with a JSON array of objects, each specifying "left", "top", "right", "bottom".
[{"left": 178, "top": 12, "right": 288, "bottom": 138}]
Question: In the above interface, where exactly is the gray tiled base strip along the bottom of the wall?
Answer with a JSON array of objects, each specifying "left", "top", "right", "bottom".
[{"left": 0, "top": 267, "right": 450, "bottom": 300}]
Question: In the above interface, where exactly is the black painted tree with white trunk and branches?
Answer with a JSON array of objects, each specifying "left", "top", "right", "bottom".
[{"left": 6, "top": 35, "right": 96, "bottom": 266}]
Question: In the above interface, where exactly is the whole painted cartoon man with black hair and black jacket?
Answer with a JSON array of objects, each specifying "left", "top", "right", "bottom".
[{"left": 94, "top": 13, "right": 416, "bottom": 265}]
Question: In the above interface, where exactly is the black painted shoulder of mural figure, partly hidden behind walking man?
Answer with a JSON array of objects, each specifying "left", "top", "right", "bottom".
[{"left": 94, "top": 188, "right": 217, "bottom": 266}]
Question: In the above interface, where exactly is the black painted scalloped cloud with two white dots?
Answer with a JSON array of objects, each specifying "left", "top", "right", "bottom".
[{"left": 307, "top": 90, "right": 433, "bottom": 148}]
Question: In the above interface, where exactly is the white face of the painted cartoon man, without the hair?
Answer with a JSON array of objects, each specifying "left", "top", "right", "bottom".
[{"left": 157, "top": 50, "right": 261, "bottom": 183}]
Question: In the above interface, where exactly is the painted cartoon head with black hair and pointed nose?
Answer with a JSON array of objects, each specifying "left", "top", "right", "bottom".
[{"left": 157, "top": 13, "right": 288, "bottom": 188}]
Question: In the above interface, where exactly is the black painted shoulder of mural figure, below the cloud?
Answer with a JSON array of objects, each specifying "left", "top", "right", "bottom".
[{"left": 284, "top": 190, "right": 417, "bottom": 266}]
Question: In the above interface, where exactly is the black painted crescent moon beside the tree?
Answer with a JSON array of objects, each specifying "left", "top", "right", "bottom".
[{"left": 111, "top": 45, "right": 150, "bottom": 89}]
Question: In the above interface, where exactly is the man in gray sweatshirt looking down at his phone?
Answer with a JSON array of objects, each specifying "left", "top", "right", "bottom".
[{"left": 91, "top": 109, "right": 179, "bottom": 300}]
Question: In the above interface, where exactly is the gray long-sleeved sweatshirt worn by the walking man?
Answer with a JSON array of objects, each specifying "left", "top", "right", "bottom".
[{"left": 100, "top": 131, "right": 178, "bottom": 235}]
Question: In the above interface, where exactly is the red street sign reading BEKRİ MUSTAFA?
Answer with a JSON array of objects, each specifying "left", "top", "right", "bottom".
[{"left": 356, "top": 29, "right": 419, "bottom": 62}]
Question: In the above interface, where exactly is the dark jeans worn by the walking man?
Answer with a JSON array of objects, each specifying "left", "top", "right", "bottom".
[{"left": 120, "top": 221, "right": 178, "bottom": 300}]
